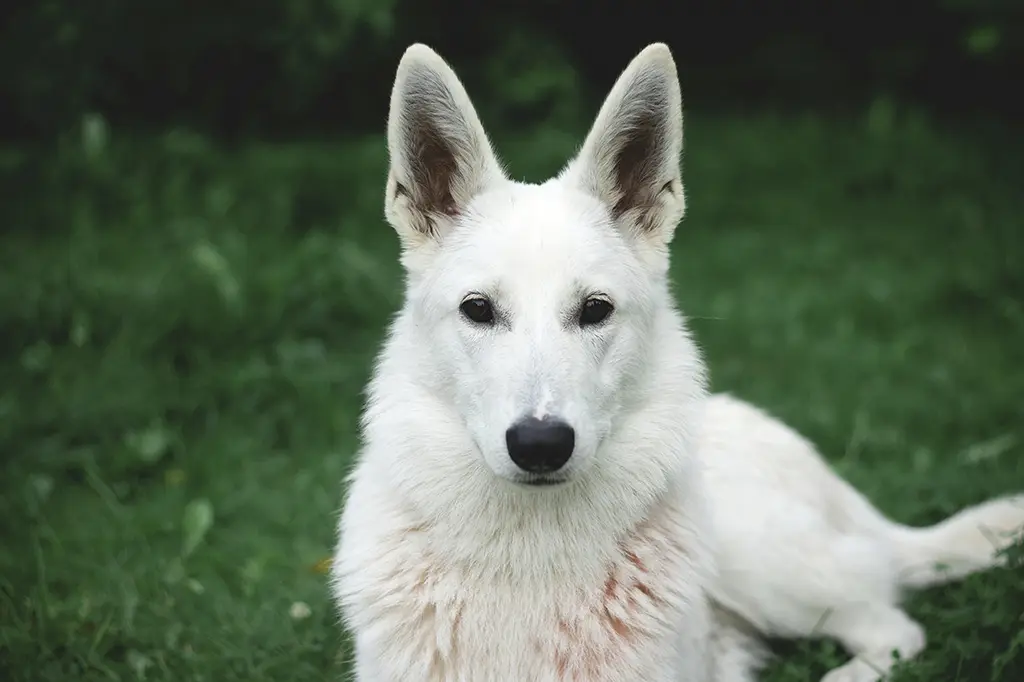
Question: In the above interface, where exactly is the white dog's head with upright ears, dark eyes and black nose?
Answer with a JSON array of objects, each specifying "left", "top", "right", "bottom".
[{"left": 385, "top": 45, "right": 685, "bottom": 485}]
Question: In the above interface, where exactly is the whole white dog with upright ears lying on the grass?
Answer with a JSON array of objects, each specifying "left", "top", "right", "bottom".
[{"left": 332, "top": 44, "right": 1024, "bottom": 682}]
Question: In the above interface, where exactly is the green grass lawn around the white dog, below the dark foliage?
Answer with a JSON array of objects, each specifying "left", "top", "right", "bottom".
[{"left": 0, "top": 109, "right": 1024, "bottom": 682}]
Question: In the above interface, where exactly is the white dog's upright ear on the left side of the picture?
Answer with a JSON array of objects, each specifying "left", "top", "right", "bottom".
[{"left": 384, "top": 44, "right": 505, "bottom": 246}]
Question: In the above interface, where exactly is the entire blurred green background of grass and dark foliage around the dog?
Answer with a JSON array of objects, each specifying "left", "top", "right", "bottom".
[{"left": 0, "top": 0, "right": 1024, "bottom": 682}]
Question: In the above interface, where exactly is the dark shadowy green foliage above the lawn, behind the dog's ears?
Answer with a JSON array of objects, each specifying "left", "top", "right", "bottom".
[{"left": 0, "top": 0, "right": 1024, "bottom": 137}]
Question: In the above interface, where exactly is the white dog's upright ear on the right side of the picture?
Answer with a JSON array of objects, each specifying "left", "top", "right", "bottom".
[{"left": 561, "top": 43, "right": 686, "bottom": 245}]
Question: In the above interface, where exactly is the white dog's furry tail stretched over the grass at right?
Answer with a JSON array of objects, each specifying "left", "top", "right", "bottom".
[{"left": 890, "top": 494, "right": 1024, "bottom": 589}]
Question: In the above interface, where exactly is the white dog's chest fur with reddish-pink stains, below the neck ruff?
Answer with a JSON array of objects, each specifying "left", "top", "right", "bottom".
[{"left": 339, "top": 499, "right": 708, "bottom": 682}]
